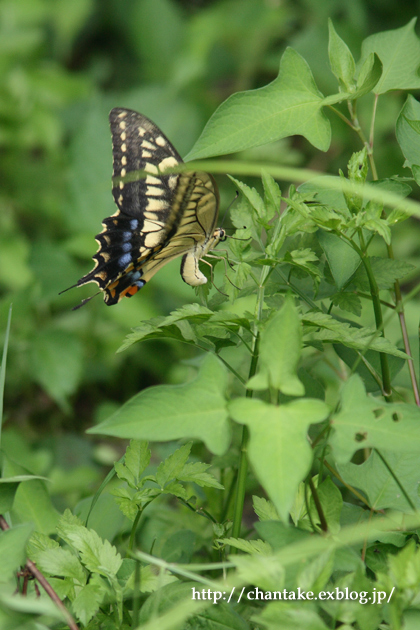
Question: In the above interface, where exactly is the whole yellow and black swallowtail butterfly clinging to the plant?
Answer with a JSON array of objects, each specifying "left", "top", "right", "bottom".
[{"left": 75, "top": 107, "right": 226, "bottom": 306}]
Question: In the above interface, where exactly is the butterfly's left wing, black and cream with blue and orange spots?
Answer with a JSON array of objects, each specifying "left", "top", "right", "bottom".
[{"left": 77, "top": 108, "right": 186, "bottom": 304}]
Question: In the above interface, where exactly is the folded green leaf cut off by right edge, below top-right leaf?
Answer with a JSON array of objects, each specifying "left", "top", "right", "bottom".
[{"left": 396, "top": 94, "right": 420, "bottom": 185}]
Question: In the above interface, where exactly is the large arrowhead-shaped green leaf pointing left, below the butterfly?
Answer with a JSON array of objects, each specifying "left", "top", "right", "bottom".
[{"left": 89, "top": 355, "right": 230, "bottom": 455}]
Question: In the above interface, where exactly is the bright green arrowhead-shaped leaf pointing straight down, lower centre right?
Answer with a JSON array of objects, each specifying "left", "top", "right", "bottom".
[{"left": 229, "top": 398, "right": 328, "bottom": 521}]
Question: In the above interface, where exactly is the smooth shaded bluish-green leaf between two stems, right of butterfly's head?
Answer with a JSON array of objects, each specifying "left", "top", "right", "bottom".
[{"left": 317, "top": 230, "right": 361, "bottom": 289}]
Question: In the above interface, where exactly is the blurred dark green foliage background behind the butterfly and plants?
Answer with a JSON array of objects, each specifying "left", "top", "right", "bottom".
[{"left": 0, "top": 0, "right": 420, "bottom": 482}]
